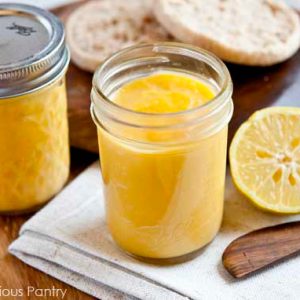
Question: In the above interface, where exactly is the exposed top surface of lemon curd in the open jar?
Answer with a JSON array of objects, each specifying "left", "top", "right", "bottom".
[{"left": 114, "top": 73, "right": 215, "bottom": 113}]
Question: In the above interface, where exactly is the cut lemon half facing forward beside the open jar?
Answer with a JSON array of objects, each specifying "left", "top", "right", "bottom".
[{"left": 230, "top": 107, "right": 300, "bottom": 213}]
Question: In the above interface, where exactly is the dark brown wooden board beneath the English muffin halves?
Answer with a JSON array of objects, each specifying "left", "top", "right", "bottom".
[{"left": 54, "top": 4, "right": 300, "bottom": 152}]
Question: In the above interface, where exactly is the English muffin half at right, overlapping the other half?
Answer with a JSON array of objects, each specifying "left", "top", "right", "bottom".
[{"left": 154, "top": 0, "right": 300, "bottom": 66}]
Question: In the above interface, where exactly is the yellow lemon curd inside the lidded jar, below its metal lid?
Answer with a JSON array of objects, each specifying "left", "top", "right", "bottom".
[{"left": 0, "top": 80, "right": 69, "bottom": 213}]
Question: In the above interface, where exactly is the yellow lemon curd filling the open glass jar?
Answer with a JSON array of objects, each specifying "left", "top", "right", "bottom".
[{"left": 98, "top": 72, "right": 227, "bottom": 258}]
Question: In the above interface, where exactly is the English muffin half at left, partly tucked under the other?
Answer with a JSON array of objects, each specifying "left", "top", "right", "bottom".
[{"left": 66, "top": 0, "right": 171, "bottom": 72}]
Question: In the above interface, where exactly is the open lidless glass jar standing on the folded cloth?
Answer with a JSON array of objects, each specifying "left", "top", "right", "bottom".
[{"left": 91, "top": 43, "right": 233, "bottom": 259}]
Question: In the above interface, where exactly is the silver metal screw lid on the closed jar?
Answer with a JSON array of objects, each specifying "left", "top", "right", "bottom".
[{"left": 0, "top": 3, "right": 70, "bottom": 99}]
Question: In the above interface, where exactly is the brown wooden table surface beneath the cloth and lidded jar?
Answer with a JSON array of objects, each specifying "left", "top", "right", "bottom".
[{"left": 0, "top": 149, "right": 98, "bottom": 300}]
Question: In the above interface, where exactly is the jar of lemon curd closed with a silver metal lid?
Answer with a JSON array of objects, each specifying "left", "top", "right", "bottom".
[{"left": 0, "top": 4, "right": 69, "bottom": 214}]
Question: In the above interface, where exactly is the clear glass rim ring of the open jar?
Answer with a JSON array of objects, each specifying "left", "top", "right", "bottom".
[{"left": 92, "top": 42, "right": 233, "bottom": 118}]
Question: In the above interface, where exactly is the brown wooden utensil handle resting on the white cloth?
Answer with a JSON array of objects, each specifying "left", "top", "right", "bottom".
[{"left": 222, "top": 222, "right": 300, "bottom": 278}]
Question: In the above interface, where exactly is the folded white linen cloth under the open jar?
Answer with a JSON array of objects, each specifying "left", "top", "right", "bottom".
[{"left": 9, "top": 163, "right": 300, "bottom": 300}]
